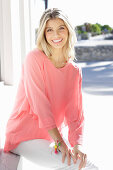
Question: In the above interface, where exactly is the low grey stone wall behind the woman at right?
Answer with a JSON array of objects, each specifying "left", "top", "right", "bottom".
[{"left": 75, "top": 45, "right": 113, "bottom": 61}]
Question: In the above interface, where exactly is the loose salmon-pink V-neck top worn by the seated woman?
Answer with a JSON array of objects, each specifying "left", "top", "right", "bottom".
[{"left": 4, "top": 49, "right": 84, "bottom": 152}]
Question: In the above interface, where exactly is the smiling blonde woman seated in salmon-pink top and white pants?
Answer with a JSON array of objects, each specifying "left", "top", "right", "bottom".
[{"left": 4, "top": 8, "right": 97, "bottom": 169}]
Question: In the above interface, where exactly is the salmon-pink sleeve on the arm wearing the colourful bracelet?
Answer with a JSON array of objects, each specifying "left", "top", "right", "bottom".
[{"left": 23, "top": 53, "right": 56, "bottom": 130}]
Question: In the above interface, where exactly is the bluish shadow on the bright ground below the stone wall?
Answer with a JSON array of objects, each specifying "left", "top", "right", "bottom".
[{"left": 82, "top": 61, "right": 113, "bottom": 95}]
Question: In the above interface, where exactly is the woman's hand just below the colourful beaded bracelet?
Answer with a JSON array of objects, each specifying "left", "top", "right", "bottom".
[{"left": 58, "top": 141, "right": 71, "bottom": 165}]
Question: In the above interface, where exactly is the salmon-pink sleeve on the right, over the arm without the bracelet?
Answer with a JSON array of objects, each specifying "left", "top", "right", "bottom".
[{"left": 67, "top": 69, "right": 84, "bottom": 147}]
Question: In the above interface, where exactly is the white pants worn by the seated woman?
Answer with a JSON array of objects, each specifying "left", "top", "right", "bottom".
[{"left": 11, "top": 139, "right": 98, "bottom": 170}]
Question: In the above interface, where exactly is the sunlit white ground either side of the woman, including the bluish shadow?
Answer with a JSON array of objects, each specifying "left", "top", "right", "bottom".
[{"left": 0, "top": 61, "right": 113, "bottom": 170}]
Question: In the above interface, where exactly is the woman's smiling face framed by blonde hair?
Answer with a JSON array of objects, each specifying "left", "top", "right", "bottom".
[{"left": 45, "top": 18, "right": 68, "bottom": 49}]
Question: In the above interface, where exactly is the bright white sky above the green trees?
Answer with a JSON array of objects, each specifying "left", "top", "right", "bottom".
[{"left": 48, "top": 0, "right": 113, "bottom": 28}]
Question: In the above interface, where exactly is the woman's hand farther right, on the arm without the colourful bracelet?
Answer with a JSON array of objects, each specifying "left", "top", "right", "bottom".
[{"left": 71, "top": 145, "right": 87, "bottom": 170}]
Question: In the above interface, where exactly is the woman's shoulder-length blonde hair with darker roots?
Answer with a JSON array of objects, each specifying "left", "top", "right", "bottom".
[{"left": 36, "top": 8, "right": 77, "bottom": 61}]
